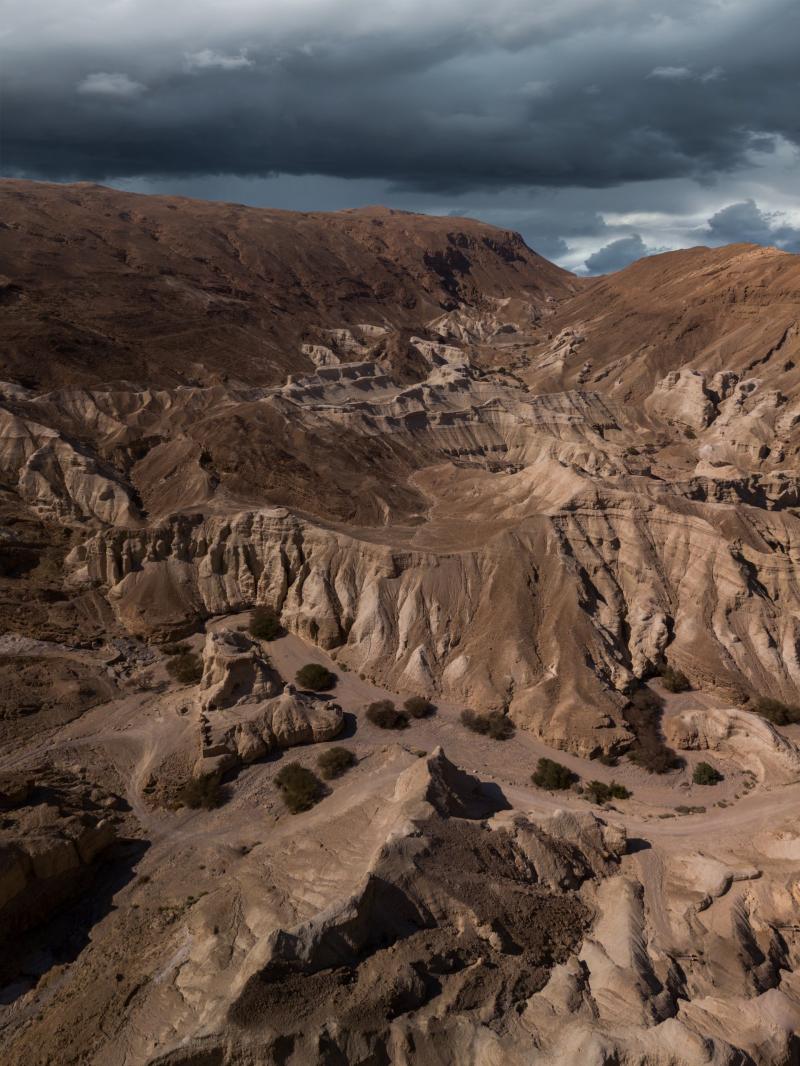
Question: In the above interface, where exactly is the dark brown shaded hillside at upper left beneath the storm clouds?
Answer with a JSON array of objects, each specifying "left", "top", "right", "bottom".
[{"left": 0, "top": 181, "right": 578, "bottom": 388}]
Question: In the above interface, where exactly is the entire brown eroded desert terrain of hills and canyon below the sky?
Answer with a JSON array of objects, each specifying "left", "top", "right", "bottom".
[{"left": 0, "top": 180, "right": 800, "bottom": 1066}]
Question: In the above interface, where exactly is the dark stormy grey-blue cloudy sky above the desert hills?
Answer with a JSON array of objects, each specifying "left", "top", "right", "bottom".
[{"left": 0, "top": 0, "right": 800, "bottom": 273}]
